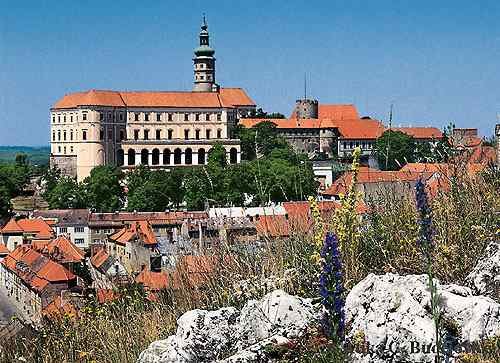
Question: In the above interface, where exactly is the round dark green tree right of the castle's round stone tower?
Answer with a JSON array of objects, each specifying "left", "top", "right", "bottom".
[{"left": 375, "top": 130, "right": 416, "bottom": 170}]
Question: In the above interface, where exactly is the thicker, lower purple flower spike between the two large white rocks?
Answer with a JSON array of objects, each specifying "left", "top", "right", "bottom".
[{"left": 319, "top": 232, "right": 345, "bottom": 340}]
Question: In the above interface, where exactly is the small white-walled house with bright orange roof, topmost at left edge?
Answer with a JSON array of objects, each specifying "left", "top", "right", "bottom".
[{"left": 0, "top": 218, "right": 54, "bottom": 251}]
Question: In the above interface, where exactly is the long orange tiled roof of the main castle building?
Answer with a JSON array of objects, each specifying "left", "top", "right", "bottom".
[{"left": 53, "top": 88, "right": 255, "bottom": 109}]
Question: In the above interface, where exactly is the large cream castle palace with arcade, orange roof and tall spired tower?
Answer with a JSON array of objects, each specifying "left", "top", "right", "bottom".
[{"left": 50, "top": 18, "right": 256, "bottom": 181}]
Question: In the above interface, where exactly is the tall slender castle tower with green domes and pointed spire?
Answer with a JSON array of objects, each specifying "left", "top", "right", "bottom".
[{"left": 193, "top": 16, "right": 217, "bottom": 92}]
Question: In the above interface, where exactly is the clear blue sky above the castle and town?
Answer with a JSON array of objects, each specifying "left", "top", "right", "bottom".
[{"left": 0, "top": 0, "right": 500, "bottom": 145}]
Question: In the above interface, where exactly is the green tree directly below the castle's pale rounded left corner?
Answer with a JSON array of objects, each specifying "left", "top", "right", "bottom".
[{"left": 83, "top": 165, "right": 125, "bottom": 212}]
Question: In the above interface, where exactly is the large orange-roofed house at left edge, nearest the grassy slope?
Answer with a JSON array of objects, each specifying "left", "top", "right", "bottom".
[{"left": 0, "top": 245, "right": 77, "bottom": 323}]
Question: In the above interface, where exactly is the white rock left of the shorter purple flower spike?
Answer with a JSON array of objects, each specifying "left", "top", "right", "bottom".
[{"left": 138, "top": 290, "right": 319, "bottom": 363}]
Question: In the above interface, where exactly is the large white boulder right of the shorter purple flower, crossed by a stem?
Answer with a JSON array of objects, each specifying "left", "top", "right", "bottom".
[{"left": 346, "top": 274, "right": 500, "bottom": 363}]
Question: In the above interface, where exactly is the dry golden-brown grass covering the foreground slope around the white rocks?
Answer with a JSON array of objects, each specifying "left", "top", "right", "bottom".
[{"left": 0, "top": 163, "right": 500, "bottom": 363}]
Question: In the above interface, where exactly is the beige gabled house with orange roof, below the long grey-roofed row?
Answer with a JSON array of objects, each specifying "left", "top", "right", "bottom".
[{"left": 106, "top": 221, "right": 159, "bottom": 274}]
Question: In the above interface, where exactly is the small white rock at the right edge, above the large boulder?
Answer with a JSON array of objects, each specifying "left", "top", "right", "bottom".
[{"left": 466, "top": 240, "right": 500, "bottom": 302}]
